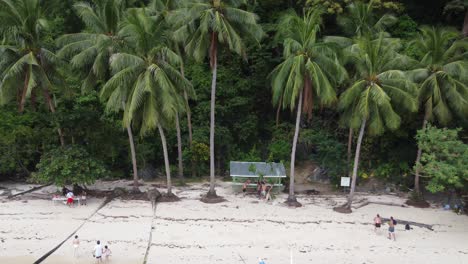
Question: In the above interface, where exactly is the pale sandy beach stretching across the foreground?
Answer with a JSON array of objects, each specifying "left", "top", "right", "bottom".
[{"left": 0, "top": 181, "right": 468, "bottom": 264}]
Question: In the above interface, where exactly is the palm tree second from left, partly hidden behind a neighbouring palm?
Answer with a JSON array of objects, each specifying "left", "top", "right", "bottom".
[{"left": 57, "top": 0, "right": 144, "bottom": 191}]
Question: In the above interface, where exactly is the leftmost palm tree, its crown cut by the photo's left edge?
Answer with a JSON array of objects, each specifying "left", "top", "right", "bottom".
[{"left": 0, "top": 0, "right": 65, "bottom": 146}]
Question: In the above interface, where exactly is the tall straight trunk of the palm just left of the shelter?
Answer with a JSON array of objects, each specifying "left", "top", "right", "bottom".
[{"left": 208, "top": 32, "right": 218, "bottom": 196}]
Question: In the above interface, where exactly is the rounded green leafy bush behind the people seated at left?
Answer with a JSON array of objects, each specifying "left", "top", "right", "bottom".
[{"left": 32, "top": 145, "right": 107, "bottom": 186}]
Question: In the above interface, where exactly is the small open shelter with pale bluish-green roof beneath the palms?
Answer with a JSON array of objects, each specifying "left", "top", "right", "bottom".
[{"left": 229, "top": 161, "right": 286, "bottom": 191}]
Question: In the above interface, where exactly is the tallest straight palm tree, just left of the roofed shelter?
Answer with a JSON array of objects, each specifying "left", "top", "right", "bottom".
[{"left": 170, "top": 0, "right": 263, "bottom": 197}]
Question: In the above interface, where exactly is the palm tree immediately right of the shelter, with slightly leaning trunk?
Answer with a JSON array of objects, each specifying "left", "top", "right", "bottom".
[{"left": 271, "top": 8, "right": 347, "bottom": 205}]
